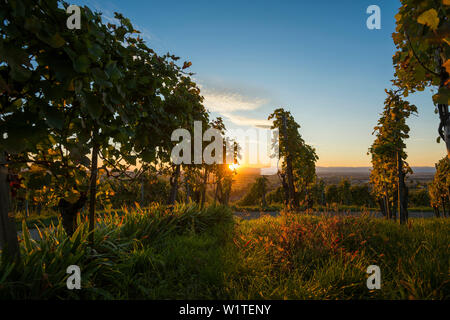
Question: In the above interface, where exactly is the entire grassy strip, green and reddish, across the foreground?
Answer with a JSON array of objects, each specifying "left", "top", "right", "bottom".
[{"left": 0, "top": 205, "right": 450, "bottom": 299}]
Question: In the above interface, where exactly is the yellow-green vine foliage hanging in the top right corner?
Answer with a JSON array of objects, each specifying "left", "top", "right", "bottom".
[{"left": 392, "top": 0, "right": 450, "bottom": 157}]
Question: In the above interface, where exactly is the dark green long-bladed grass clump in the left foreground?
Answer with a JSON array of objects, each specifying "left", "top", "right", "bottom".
[{"left": 0, "top": 204, "right": 232, "bottom": 299}]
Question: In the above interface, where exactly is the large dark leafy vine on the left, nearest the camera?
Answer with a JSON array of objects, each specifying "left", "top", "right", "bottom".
[{"left": 0, "top": 0, "right": 204, "bottom": 242}]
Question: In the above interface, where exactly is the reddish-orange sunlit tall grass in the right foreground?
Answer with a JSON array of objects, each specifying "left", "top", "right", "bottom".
[{"left": 226, "top": 214, "right": 450, "bottom": 299}]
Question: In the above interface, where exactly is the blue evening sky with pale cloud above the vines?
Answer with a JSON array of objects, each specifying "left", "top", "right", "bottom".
[{"left": 71, "top": 0, "right": 446, "bottom": 167}]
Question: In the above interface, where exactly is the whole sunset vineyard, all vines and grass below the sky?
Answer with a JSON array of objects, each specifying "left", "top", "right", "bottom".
[{"left": 0, "top": 0, "right": 450, "bottom": 300}]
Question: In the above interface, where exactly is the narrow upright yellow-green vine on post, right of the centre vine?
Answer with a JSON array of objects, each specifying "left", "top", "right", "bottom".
[{"left": 369, "top": 90, "right": 417, "bottom": 223}]
